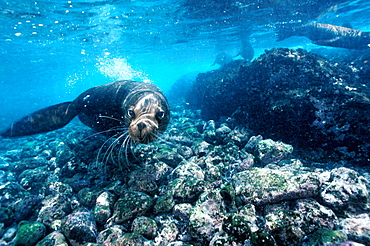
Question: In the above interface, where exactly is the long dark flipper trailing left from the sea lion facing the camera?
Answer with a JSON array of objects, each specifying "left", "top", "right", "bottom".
[{"left": 0, "top": 102, "right": 78, "bottom": 137}]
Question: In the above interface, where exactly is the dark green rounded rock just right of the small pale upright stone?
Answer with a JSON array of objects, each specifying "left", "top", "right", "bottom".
[{"left": 107, "top": 191, "right": 153, "bottom": 225}]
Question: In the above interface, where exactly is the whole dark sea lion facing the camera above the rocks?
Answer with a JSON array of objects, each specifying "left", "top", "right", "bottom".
[{"left": 0, "top": 80, "right": 170, "bottom": 144}]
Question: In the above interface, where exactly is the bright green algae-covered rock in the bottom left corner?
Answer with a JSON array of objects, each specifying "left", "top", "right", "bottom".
[{"left": 14, "top": 220, "right": 46, "bottom": 246}]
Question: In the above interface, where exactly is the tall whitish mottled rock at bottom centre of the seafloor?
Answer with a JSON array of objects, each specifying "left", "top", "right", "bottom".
[{"left": 189, "top": 189, "right": 226, "bottom": 242}]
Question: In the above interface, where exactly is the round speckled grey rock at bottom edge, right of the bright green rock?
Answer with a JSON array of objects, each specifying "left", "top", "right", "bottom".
[{"left": 61, "top": 208, "right": 98, "bottom": 243}]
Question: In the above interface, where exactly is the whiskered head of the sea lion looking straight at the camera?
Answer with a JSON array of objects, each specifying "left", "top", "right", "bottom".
[{"left": 125, "top": 90, "right": 170, "bottom": 144}]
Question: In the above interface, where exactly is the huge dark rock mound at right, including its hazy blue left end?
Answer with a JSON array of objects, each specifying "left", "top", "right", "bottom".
[{"left": 187, "top": 48, "right": 370, "bottom": 163}]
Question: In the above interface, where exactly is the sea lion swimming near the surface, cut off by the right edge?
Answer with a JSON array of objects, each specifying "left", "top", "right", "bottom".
[{"left": 278, "top": 23, "right": 370, "bottom": 50}]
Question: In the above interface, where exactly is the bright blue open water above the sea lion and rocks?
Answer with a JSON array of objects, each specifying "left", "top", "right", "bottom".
[{"left": 0, "top": 0, "right": 370, "bottom": 128}]
